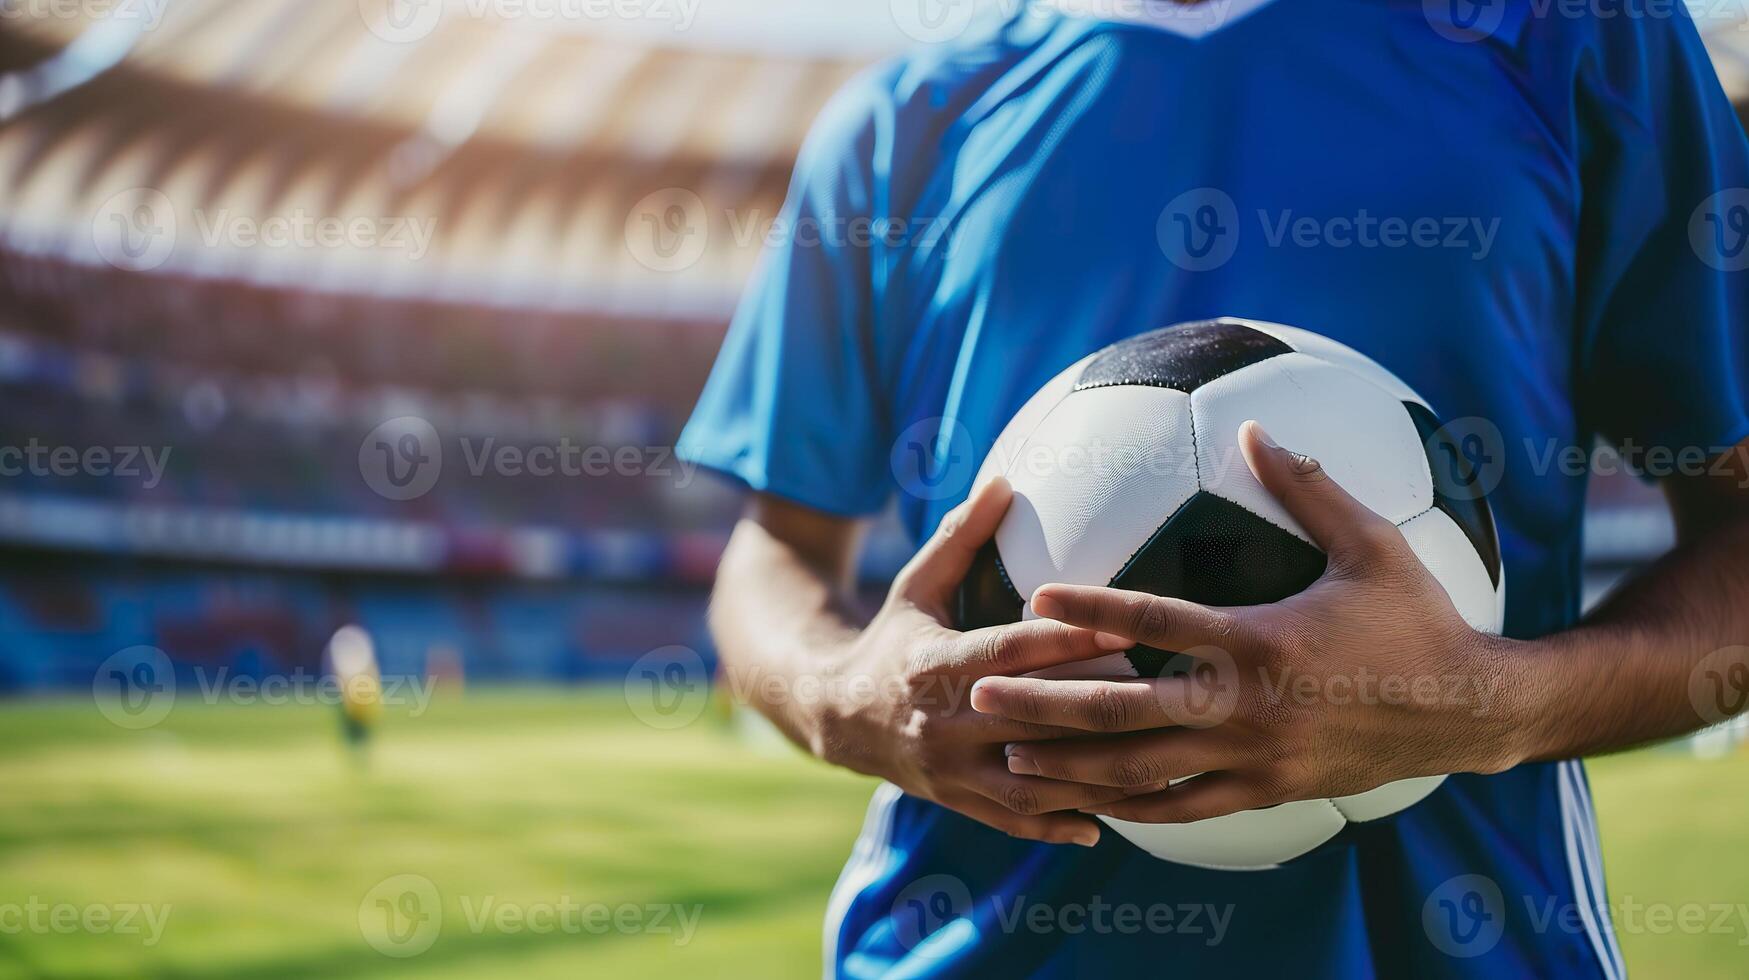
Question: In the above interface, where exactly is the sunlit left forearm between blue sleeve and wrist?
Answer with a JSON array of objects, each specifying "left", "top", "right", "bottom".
[{"left": 710, "top": 520, "right": 864, "bottom": 754}]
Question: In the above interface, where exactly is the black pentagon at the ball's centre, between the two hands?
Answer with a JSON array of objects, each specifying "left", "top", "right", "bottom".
[{"left": 1111, "top": 492, "right": 1326, "bottom": 677}]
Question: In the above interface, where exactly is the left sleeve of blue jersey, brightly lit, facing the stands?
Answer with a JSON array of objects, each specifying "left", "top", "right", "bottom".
[{"left": 677, "top": 66, "right": 892, "bottom": 516}]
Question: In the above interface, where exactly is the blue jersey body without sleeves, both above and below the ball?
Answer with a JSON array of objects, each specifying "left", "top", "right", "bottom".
[{"left": 827, "top": 9, "right": 1623, "bottom": 977}]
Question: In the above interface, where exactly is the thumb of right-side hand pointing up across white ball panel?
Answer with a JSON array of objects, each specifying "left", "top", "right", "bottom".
[{"left": 1238, "top": 420, "right": 1403, "bottom": 557}]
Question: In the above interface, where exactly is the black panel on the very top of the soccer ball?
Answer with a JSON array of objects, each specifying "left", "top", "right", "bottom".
[{"left": 1076, "top": 320, "right": 1294, "bottom": 394}]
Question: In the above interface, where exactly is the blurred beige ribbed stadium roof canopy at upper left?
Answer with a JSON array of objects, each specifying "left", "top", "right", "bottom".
[{"left": 0, "top": 0, "right": 881, "bottom": 319}]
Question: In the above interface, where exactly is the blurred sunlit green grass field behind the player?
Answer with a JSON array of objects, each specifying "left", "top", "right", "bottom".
[{"left": 0, "top": 690, "right": 1749, "bottom": 980}]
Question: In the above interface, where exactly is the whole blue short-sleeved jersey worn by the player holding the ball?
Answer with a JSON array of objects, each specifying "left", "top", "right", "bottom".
[{"left": 682, "top": 0, "right": 1749, "bottom": 978}]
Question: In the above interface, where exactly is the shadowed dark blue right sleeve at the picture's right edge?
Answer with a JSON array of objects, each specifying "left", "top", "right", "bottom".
[{"left": 1578, "top": 11, "right": 1749, "bottom": 450}]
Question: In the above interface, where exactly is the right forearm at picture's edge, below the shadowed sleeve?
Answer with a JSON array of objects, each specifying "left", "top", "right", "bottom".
[{"left": 1501, "top": 520, "right": 1749, "bottom": 761}]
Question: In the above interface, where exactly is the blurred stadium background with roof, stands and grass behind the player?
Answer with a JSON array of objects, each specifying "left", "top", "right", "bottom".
[{"left": 0, "top": 0, "right": 1749, "bottom": 977}]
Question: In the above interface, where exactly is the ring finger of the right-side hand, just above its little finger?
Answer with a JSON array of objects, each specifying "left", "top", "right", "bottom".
[{"left": 1007, "top": 730, "right": 1244, "bottom": 796}]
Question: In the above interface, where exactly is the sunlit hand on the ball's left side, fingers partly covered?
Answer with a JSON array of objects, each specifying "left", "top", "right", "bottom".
[{"left": 813, "top": 478, "right": 1133, "bottom": 847}]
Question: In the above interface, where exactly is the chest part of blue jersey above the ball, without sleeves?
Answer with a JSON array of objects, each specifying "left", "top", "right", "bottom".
[{"left": 876, "top": 4, "right": 1583, "bottom": 632}]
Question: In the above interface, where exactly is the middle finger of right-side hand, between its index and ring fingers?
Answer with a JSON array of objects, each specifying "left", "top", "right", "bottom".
[{"left": 971, "top": 677, "right": 1182, "bottom": 733}]
